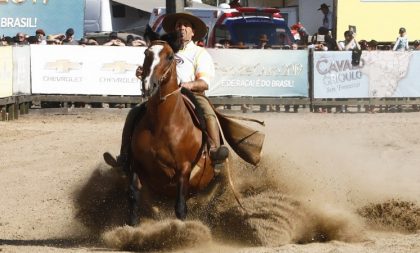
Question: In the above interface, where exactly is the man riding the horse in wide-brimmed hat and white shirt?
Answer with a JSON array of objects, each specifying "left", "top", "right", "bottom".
[{"left": 104, "top": 12, "right": 229, "bottom": 170}]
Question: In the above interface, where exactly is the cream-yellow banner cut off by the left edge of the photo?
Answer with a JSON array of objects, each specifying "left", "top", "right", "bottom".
[{"left": 0, "top": 46, "right": 13, "bottom": 98}]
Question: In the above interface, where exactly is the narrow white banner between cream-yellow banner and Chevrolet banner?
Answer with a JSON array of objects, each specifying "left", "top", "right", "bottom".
[{"left": 13, "top": 46, "right": 31, "bottom": 95}]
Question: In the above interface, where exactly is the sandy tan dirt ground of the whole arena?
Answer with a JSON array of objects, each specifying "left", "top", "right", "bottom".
[{"left": 0, "top": 109, "right": 420, "bottom": 253}]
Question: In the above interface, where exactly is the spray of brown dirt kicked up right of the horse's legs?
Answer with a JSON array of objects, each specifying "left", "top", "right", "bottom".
[{"left": 211, "top": 160, "right": 364, "bottom": 247}]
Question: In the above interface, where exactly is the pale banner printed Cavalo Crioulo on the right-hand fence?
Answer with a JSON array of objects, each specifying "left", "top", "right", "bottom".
[{"left": 313, "top": 51, "right": 420, "bottom": 98}]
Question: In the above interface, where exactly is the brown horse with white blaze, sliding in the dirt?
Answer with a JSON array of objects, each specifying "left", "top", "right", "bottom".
[{"left": 130, "top": 41, "right": 215, "bottom": 223}]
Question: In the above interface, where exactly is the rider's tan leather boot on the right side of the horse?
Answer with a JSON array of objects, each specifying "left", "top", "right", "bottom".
[{"left": 206, "top": 117, "right": 229, "bottom": 164}]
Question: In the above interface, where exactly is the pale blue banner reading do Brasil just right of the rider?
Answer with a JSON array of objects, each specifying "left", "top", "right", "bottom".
[{"left": 206, "top": 49, "right": 308, "bottom": 97}]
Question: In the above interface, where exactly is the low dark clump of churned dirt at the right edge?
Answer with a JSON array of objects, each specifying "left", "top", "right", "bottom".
[{"left": 358, "top": 199, "right": 420, "bottom": 232}]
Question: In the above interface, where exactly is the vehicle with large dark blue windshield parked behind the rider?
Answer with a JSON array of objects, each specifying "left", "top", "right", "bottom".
[{"left": 149, "top": 7, "right": 294, "bottom": 47}]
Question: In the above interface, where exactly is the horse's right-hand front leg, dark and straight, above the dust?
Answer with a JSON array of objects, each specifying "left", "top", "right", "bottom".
[{"left": 175, "top": 163, "right": 191, "bottom": 220}]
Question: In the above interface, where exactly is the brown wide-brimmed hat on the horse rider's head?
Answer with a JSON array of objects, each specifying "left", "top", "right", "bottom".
[{"left": 162, "top": 12, "right": 207, "bottom": 41}]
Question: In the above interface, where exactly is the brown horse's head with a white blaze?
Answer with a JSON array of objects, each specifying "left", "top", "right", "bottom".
[{"left": 137, "top": 40, "right": 175, "bottom": 97}]
